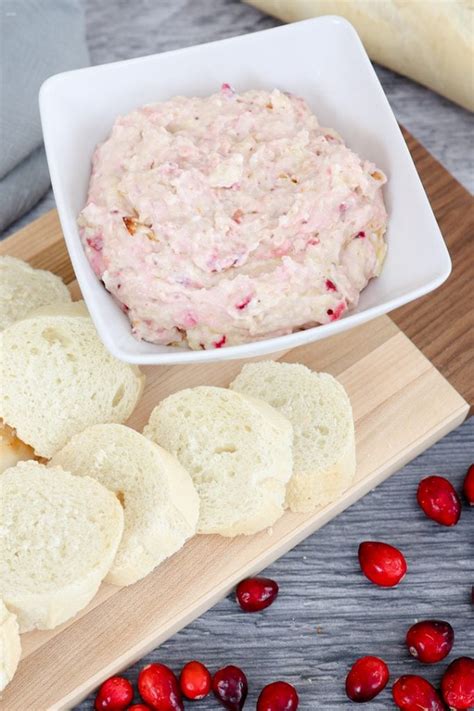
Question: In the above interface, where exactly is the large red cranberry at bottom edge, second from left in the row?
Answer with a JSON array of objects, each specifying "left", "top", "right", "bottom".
[{"left": 138, "top": 664, "right": 184, "bottom": 711}]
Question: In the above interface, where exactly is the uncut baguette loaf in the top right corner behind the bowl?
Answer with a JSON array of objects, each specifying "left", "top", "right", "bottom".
[{"left": 246, "top": 0, "right": 474, "bottom": 111}]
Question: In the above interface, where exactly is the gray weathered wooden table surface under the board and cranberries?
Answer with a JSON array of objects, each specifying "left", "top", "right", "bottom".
[{"left": 10, "top": 0, "right": 474, "bottom": 711}]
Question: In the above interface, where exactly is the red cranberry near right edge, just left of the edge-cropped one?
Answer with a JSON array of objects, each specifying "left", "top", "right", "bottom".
[{"left": 416, "top": 476, "right": 461, "bottom": 526}]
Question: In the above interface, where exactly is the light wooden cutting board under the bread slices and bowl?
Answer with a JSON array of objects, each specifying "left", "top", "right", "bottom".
[{"left": 0, "top": 129, "right": 469, "bottom": 711}]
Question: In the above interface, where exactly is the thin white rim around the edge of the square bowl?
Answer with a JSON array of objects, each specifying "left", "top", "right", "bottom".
[{"left": 39, "top": 15, "right": 452, "bottom": 365}]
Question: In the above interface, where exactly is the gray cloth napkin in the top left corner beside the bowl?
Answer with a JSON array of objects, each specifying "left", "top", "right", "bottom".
[{"left": 0, "top": 0, "right": 89, "bottom": 232}]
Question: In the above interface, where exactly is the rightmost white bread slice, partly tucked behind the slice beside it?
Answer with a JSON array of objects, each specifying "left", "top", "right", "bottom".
[{"left": 230, "top": 361, "right": 356, "bottom": 512}]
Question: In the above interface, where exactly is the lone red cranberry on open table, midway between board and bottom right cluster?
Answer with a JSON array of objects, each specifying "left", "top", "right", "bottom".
[{"left": 359, "top": 541, "right": 407, "bottom": 588}]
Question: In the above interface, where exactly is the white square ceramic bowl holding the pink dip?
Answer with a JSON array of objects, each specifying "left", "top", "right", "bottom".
[{"left": 40, "top": 16, "right": 451, "bottom": 364}]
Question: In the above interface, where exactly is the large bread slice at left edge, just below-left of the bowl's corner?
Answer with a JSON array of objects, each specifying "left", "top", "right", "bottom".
[{"left": 0, "top": 302, "right": 144, "bottom": 459}]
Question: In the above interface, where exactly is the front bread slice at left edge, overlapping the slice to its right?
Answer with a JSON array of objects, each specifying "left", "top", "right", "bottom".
[{"left": 0, "top": 461, "right": 123, "bottom": 632}]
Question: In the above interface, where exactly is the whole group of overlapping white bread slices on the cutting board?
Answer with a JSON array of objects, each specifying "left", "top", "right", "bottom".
[{"left": 0, "top": 258, "right": 355, "bottom": 690}]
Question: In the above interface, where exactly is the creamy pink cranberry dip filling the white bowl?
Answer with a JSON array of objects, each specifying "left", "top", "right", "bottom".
[{"left": 79, "top": 84, "right": 387, "bottom": 349}]
